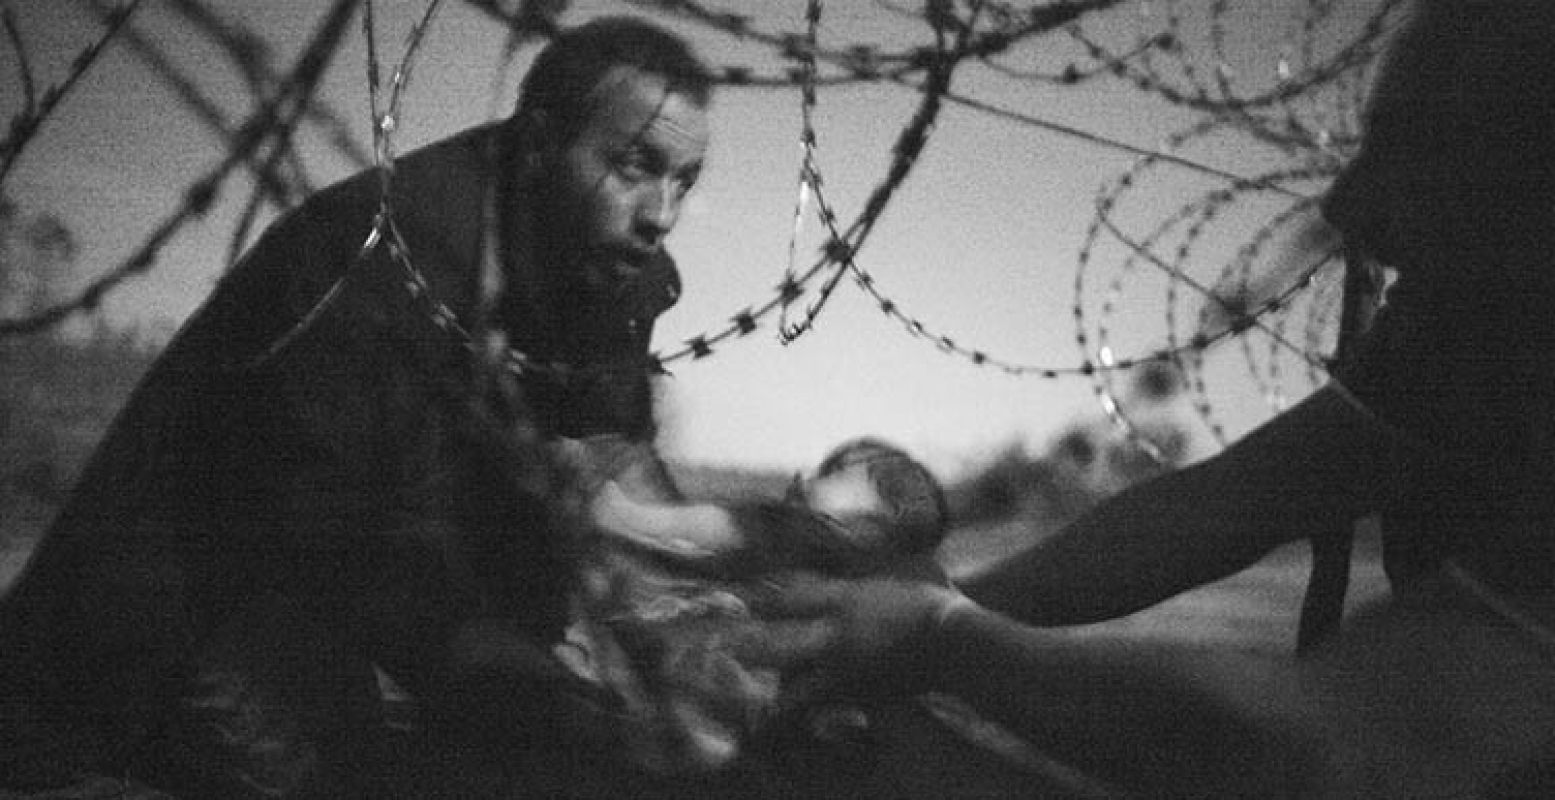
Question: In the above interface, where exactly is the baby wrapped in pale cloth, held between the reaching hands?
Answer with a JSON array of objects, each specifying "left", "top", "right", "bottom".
[{"left": 558, "top": 439, "right": 947, "bottom": 772}]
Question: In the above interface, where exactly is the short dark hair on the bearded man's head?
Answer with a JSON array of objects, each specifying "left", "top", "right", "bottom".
[{"left": 515, "top": 17, "right": 712, "bottom": 142}]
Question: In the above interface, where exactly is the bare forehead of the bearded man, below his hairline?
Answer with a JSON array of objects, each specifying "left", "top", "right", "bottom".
[{"left": 591, "top": 65, "right": 709, "bottom": 153}]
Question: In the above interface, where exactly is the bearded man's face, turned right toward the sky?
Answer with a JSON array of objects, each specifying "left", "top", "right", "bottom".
[{"left": 541, "top": 67, "right": 709, "bottom": 305}]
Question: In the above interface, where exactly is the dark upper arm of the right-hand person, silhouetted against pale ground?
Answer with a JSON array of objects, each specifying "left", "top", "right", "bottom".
[{"left": 961, "top": 388, "right": 1406, "bottom": 624}]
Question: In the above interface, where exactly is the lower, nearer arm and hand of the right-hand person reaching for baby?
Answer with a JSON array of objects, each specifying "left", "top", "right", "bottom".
[{"left": 742, "top": 574, "right": 1330, "bottom": 798}]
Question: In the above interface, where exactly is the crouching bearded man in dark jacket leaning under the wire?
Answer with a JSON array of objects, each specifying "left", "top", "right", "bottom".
[{"left": 0, "top": 17, "right": 712, "bottom": 797}]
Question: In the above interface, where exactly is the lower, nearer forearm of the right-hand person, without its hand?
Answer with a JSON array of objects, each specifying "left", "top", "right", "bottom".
[{"left": 927, "top": 604, "right": 1322, "bottom": 797}]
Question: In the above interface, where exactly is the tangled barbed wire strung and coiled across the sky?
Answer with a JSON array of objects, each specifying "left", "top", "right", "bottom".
[{"left": 0, "top": 0, "right": 1403, "bottom": 436}]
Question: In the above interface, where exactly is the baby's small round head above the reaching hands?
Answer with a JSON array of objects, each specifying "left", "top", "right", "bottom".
[{"left": 788, "top": 437, "right": 950, "bottom": 556}]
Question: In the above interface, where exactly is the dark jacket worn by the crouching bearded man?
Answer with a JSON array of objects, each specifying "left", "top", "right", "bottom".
[{"left": 0, "top": 126, "right": 678, "bottom": 784}]
